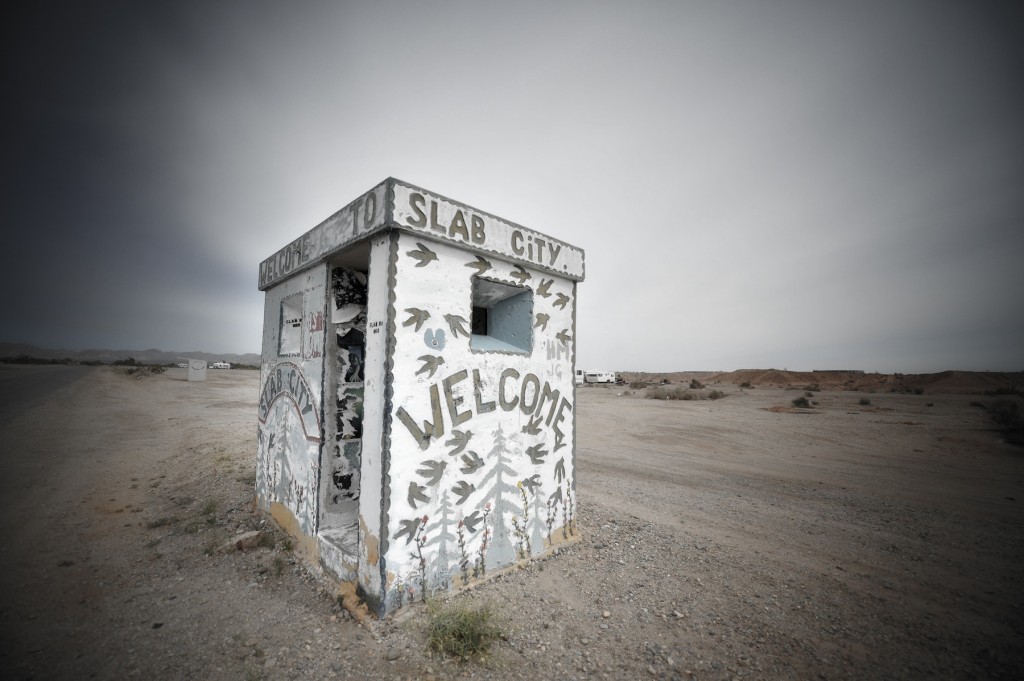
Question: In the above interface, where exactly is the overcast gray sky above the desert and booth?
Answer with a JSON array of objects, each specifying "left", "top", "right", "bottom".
[{"left": 0, "top": 0, "right": 1024, "bottom": 372}]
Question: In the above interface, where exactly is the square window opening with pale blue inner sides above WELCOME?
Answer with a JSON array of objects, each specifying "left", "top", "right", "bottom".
[{"left": 469, "top": 276, "right": 534, "bottom": 354}]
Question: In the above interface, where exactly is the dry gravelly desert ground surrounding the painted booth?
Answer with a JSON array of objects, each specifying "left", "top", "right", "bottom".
[{"left": 0, "top": 366, "right": 1024, "bottom": 679}]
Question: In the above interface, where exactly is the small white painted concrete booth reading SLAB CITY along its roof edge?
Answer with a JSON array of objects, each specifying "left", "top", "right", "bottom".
[{"left": 256, "top": 178, "right": 584, "bottom": 615}]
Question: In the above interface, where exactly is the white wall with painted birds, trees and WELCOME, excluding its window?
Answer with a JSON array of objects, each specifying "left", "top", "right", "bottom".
[{"left": 383, "top": 232, "right": 575, "bottom": 609}]
